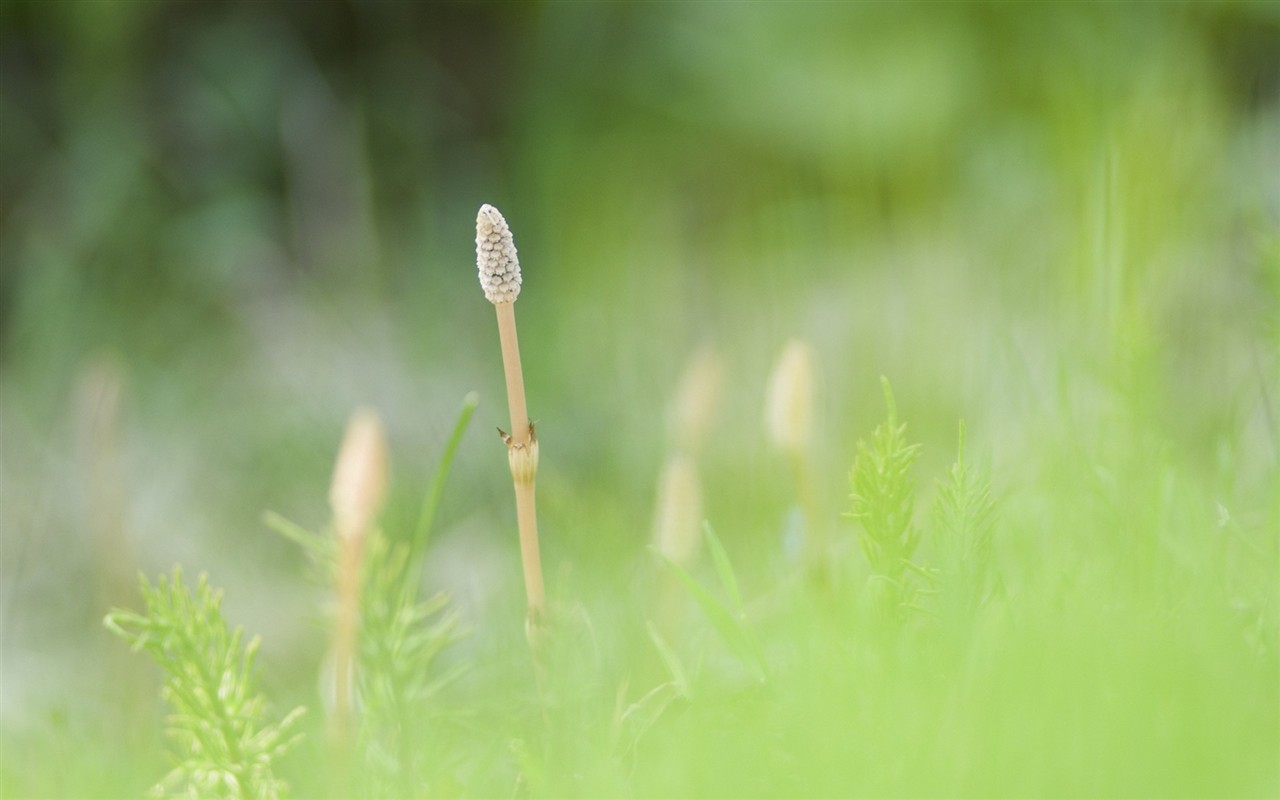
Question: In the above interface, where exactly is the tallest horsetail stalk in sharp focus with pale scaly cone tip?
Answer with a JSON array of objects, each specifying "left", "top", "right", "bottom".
[{"left": 476, "top": 204, "right": 548, "bottom": 655}]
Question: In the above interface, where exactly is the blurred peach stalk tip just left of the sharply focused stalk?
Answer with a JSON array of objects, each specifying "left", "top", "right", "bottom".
[{"left": 329, "top": 408, "right": 387, "bottom": 539}]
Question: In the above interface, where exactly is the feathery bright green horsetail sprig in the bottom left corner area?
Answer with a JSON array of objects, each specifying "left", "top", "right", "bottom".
[{"left": 104, "top": 568, "right": 303, "bottom": 800}]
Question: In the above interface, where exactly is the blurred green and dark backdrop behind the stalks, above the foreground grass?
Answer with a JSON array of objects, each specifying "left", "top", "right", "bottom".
[{"left": 0, "top": 0, "right": 1280, "bottom": 796}]
